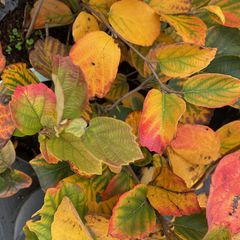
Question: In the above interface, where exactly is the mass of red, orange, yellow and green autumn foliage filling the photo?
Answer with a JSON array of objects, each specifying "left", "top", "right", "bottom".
[{"left": 0, "top": 0, "right": 240, "bottom": 240}]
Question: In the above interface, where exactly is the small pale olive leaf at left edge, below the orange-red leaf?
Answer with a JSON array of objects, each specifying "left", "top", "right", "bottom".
[{"left": 0, "top": 141, "right": 16, "bottom": 174}]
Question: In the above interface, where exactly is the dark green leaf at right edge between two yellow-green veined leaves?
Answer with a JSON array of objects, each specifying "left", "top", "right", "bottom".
[{"left": 204, "top": 56, "right": 240, "bottom": 78}]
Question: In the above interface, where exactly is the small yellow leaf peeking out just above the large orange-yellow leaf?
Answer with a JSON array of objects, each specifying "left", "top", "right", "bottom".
[{"left": 72, "top": 11, "right": 99, "bottom": 42}]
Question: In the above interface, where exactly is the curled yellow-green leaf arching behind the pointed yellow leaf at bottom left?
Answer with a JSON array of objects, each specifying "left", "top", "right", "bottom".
[{"left": 27, "top": 183, "right": 87, "bottom": 240}]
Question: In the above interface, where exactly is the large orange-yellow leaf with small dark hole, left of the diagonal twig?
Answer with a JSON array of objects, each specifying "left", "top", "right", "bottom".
[{"left": 70, "top": 31, "right": 121, "bottom": 98}]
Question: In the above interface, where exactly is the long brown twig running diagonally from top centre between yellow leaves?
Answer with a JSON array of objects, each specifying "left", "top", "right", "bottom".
[{"left": 82, "top": 3, "right": 182, "bottom": 96}]
